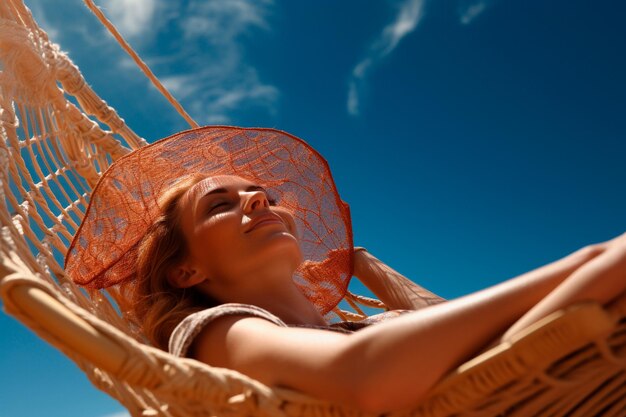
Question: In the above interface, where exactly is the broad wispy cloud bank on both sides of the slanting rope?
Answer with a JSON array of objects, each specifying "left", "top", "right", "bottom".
[{"left": 26, "top": 0, "right": 280, "bottom": 124}]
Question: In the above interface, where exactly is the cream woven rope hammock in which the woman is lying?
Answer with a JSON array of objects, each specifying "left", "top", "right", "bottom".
[{"left": 0, "top": 0, "right": 626, "bottom": 417}]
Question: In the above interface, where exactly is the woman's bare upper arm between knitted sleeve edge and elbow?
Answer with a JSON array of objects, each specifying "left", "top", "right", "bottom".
[{"left": 188, "top": 308, "right": 351, "bottom": 389}]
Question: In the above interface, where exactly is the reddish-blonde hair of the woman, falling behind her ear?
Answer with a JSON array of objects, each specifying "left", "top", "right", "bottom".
[{"left": 131, "top": 174, "right": 219, "bottom": 350}]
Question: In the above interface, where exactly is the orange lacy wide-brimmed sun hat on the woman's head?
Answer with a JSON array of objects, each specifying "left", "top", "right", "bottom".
[{"left": 65, "top": 126, "right": 352, "bottom": 314}]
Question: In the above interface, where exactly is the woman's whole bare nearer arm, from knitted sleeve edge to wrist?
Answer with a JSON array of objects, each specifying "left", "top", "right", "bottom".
[{"left": 192, "top": 247, "right": 598, "bottom": 412}]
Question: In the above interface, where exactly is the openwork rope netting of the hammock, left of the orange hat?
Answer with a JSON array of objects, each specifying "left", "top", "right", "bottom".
[{"left": 0, "top": 1, "right": 145, "bottom": 318}]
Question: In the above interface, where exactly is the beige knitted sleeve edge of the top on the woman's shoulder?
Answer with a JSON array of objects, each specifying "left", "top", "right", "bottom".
[{"left": 168, "top": 303, "right": 287, "bottom": 356}]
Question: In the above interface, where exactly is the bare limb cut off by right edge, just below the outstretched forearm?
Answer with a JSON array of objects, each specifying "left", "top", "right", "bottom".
[{"left": 501, "top": 235, "right": 626, "bottom": 340}]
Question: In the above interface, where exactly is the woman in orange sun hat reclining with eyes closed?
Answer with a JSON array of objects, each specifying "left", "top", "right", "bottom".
[{"left": 66, "top": 127, "right": 626, "bottom": 412}]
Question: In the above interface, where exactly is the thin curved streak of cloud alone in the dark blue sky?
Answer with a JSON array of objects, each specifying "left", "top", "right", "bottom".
[{"left": 347, "top": 0, "right": 424, "bottom": 116}]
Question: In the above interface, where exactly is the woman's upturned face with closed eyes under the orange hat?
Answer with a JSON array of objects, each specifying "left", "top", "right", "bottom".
[{"left": 173, "top": 175, "right": 302, "bottom": 285}]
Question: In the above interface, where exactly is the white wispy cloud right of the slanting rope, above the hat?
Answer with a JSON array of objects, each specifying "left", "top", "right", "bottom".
[{"left": 98, "top": 0, "right": 279, "bottom": 124}]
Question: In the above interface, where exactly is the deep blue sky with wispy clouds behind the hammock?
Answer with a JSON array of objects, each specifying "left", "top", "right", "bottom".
[{"left": 0, "top": 0, "right": 626, "bottom": 417}]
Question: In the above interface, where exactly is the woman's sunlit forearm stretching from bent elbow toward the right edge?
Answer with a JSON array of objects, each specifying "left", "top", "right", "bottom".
[{"left": 344, "top": 244, "right": 599, "bottom": 411}]
